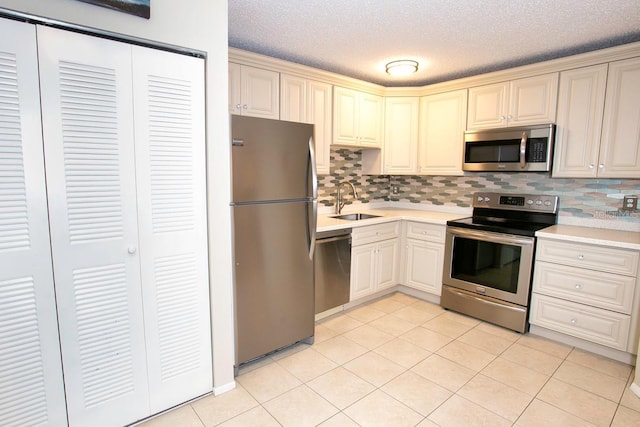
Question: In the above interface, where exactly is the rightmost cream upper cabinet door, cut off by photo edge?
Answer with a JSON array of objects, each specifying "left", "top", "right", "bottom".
[{"left": 598, "top": 58, "right": 640, "bottom": 178}]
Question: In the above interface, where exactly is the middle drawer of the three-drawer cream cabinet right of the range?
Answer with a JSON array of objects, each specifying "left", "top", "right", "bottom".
[{"left": 533, "top": 261, "right": 635, "bottom": 314}]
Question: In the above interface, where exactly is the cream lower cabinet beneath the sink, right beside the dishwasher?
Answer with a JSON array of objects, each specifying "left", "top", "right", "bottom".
[{"left": 350, "top": 221, "right": 400, "bottom": 301}]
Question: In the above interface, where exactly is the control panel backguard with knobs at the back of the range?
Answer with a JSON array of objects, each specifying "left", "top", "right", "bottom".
[{"left": 473, "top": 192, "right": 558, "bottom": 213}]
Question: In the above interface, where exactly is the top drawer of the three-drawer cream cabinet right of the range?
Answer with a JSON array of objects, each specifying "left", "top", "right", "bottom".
[{"left": 536, "top": 239, "right": 638, "bottom": 276}]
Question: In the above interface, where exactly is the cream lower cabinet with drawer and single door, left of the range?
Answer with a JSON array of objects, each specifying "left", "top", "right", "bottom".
[{"left": 403, "top": 221, "right": 445, "bottom": 295}]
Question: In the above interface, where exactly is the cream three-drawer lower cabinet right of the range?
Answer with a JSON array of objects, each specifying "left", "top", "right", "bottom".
[{"left": 529, "top": 238, "right": 640, "bottom": 354}]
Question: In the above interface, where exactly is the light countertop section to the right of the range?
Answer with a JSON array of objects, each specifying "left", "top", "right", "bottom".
[{"left": 536, "top": 224, "right": 640, "bottom": 250}]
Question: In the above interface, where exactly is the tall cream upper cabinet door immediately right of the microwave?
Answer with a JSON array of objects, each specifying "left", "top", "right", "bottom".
[{"left": 553, "top": 64, "right": 607, "bottom": 178}]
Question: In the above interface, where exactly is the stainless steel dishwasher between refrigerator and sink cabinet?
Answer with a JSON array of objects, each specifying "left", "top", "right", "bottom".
[{"left": 315, "top": 228, "right": 351, "bottom": 314}]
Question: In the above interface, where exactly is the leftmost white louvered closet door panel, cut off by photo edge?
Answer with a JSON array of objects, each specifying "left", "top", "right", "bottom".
[{"left": 0, "top": 19, "right": 66, "bottom": 427}]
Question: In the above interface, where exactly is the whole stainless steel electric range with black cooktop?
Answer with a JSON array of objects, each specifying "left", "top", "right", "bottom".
[{"left": 440, "top": 192, "right": 558, "bottom": 332}]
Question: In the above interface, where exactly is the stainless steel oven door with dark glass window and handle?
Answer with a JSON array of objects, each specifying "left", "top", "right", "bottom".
[{"left": 443, "top": 226, "right": 535, "bottom": 307}]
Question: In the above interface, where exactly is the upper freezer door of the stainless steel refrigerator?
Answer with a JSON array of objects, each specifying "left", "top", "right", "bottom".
[{"left": 231, "top": 115, "right": 316, "bottom": 204}]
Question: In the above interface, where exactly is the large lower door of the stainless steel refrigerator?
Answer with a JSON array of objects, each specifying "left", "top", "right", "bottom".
[{"left": 233, "top": 202, "right": 314, "bottom": 367}]
